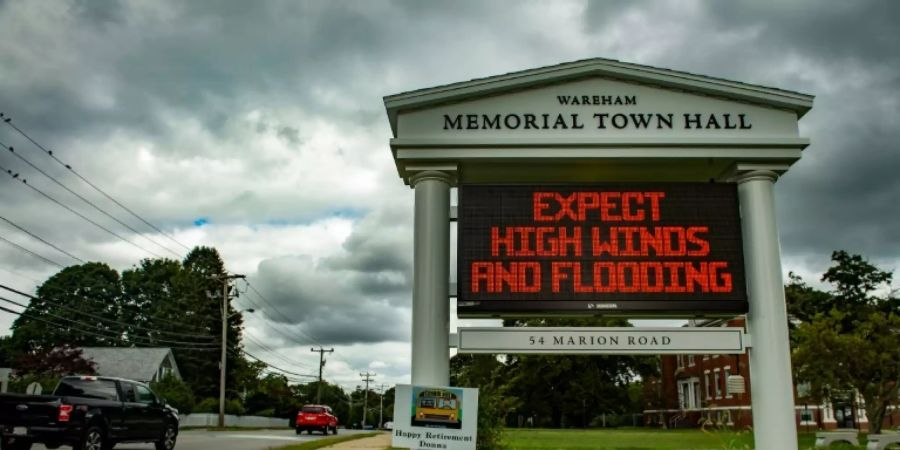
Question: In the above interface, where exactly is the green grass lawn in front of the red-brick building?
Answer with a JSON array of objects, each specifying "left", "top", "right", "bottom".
[{"left": 506, "top": 428, "right": 865, "bottom": 450}]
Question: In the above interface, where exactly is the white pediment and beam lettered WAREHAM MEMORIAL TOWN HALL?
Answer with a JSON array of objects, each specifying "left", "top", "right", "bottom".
[{"left": 384, "top": 59, "right": 813, "bottom": 182}]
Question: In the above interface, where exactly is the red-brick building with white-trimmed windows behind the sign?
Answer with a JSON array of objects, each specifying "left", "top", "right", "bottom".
[{"left": 644, "top": 317, "right": 900, "bottom": 431}]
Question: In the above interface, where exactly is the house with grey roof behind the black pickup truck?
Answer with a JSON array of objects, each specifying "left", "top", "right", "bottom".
[{"left": 79, "top": 347, "right": 181, "bottom": 383}]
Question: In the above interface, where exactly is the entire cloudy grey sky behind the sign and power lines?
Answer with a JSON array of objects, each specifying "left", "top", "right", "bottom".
[{"left": 0, "top": 0, "right": 900, "bottom": 387}]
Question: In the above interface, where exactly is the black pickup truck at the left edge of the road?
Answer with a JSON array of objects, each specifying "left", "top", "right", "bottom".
[{"left": 0, "top": 377, "right": 178, "bottom": 450}]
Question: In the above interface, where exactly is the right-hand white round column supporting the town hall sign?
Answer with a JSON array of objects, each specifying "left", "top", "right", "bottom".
[{"left": 737, "top": 170, "right": 797, "bottom": 450}]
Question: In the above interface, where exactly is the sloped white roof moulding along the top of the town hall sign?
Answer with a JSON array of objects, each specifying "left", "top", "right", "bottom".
[{"left": 384, "top": 58, "right": 813, "bottom": 137}]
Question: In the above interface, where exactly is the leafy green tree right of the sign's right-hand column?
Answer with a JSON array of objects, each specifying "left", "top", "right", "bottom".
[{"left": 789, "top": 251, "right": 900, "bottom": 433}]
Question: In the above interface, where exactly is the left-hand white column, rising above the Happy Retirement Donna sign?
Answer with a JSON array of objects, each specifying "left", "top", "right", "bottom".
[{"left": 409, "top": 171, "right": 454, "bottom": 386}]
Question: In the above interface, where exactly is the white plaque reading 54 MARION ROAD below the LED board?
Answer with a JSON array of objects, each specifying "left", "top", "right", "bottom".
[{"left": 457, "top": 327, "right": 749, "bottom": 355}]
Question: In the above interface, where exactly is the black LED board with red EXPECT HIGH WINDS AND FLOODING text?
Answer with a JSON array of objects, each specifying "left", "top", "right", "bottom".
[{"left": 457, "top": 183, "right": 747, "bottom": 317}]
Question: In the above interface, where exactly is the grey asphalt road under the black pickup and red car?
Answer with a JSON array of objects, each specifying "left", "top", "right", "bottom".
[{"left": 31, "top": 428, "right": 370, "bottom": 450}]
